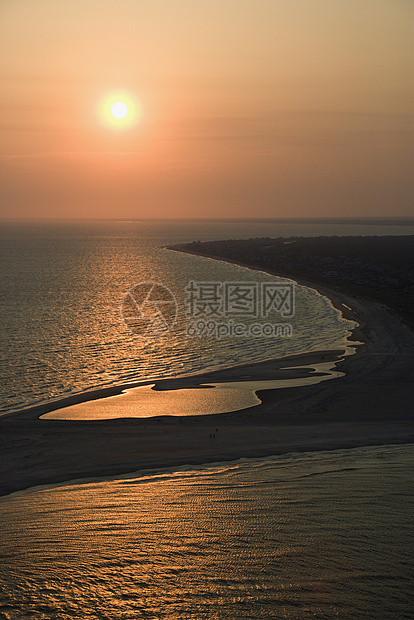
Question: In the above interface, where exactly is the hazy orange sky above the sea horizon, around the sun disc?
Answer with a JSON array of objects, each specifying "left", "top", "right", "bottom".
[{"left": 0, "top": 0, "right": 414, "bottom": 218}]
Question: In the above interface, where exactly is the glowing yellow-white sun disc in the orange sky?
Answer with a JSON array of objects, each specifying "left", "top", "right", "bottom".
[{"left": 98, "top": 91, "right": 141, "bottom": 129}]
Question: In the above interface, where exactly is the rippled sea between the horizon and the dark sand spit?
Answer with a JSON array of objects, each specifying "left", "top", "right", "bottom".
[{"left": 0, "top": 222, "right": 368, "bottom": 411}]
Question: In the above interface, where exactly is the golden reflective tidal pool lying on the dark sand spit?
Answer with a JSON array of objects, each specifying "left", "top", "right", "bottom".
[{"left": 41, "top": 347, "right": 346, "bottom": 420}]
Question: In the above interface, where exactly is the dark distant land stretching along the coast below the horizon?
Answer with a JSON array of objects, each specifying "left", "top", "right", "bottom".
[{"left": 167, "top": 235, "right": 414, "bottom": 327}]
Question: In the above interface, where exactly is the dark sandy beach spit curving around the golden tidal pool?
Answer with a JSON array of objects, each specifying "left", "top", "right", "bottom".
[{"left": 0, "top": 260, "right": 414, "bottom": 495}]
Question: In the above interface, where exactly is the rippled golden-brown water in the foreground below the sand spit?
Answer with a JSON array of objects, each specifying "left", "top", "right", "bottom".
[{"left": 0, "top": 446, "right": 414, "bottom": 620}]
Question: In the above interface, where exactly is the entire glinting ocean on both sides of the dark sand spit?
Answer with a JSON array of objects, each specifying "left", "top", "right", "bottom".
[{"left": 0, "top": 221, "right": 414, "bottom": 620}]
